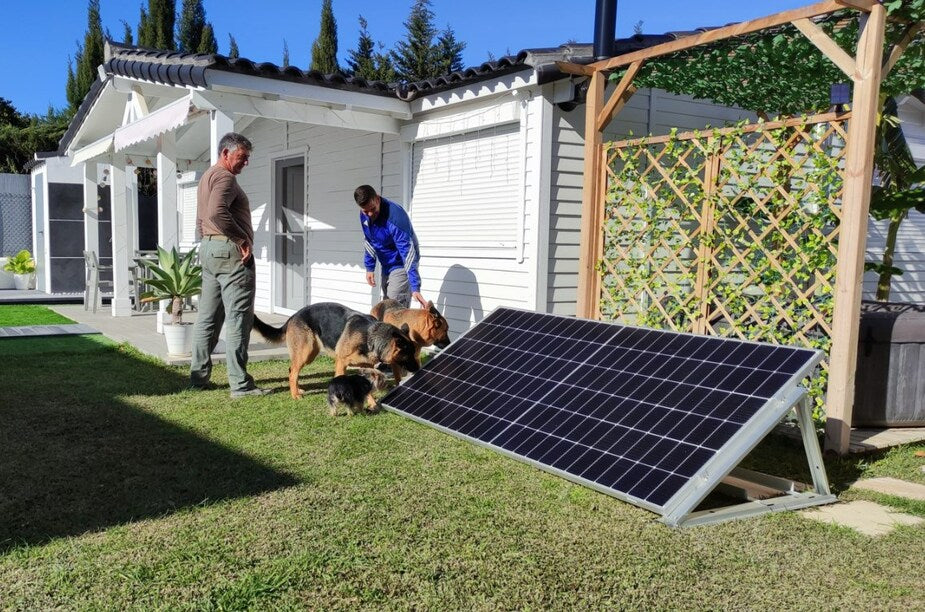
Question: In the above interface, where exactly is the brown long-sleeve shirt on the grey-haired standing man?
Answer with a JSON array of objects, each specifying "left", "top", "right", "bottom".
[{"left": 196, "top": 164, "right": 254, "bottom": 246}]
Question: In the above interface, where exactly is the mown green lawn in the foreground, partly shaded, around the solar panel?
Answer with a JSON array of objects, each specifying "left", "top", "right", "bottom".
[{"left": 0, "top": 336, "right": 925, "bottom": 610}]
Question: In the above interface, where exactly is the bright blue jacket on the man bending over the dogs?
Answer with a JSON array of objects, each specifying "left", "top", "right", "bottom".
[{"left": 360, "top": 196, "right": 421, "bottom": 291}]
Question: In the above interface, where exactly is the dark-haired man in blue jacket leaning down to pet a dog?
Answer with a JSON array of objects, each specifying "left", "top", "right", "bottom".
[{"left": 353, "top": 185, "right": 427, "bottom": 308}]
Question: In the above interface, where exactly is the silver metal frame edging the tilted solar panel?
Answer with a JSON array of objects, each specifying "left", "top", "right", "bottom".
[{"left": 382, "top": 307, "right": 823, "bottom": 524}]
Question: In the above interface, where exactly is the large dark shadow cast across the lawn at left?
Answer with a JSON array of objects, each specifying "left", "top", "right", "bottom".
[{"left": 0, "top": 336, "right": 299, "bottom": 552}]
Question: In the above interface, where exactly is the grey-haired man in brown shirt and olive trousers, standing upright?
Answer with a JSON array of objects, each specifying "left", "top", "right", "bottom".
[{"left": 190, "top": 132, "right": 269, "bottom": 397}]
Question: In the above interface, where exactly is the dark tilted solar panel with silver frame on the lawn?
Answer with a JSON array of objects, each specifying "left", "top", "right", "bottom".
[{"left": 382, "top": 308, "right": 828, "bottom": 524}]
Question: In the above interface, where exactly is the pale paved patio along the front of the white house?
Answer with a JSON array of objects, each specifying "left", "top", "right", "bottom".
[{"left": 47, "top": 304, "right": 289, "bottom": 365}]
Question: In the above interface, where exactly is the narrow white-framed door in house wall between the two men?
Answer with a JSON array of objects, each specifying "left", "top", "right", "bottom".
[{"left": 273, "top": 156, "right": 307, "bottom": 314}]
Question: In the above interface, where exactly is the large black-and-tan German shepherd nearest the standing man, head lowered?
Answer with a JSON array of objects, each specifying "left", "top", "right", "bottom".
[{"left": 254, "top": 302, "right": 420, "bottom": 399}]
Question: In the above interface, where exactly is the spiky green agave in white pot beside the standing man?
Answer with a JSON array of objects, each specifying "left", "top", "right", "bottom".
[{"left": 141, "top": 247, "right": 202, "bottom": 355}]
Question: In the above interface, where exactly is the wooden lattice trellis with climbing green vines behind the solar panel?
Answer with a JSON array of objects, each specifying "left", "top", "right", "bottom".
[{"left": 597, "top": 113, "right": 848, "bottom": 406}]
